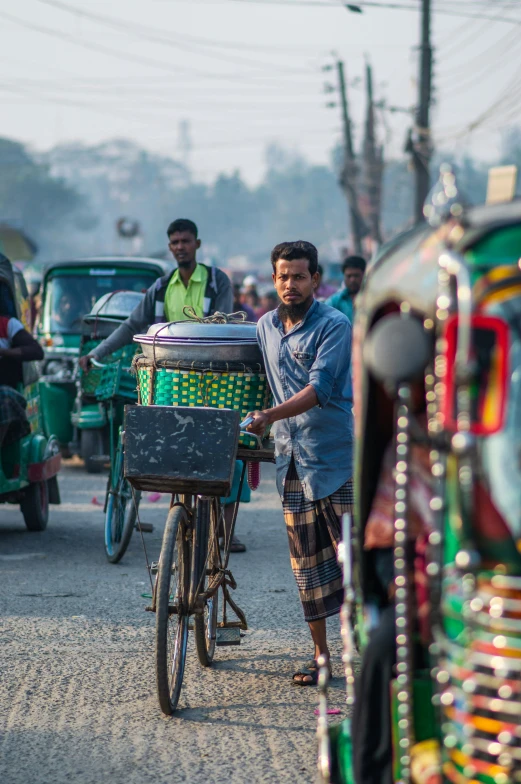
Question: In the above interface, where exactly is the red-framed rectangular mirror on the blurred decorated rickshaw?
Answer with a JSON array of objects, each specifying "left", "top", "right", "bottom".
[{"left": 441, "top": 314, "right": 509, "bottom": 436}]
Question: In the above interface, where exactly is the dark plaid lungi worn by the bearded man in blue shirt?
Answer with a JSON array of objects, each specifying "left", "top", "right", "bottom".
[{"left": 282, "top": 459, "right": 353, "bottom": 621}]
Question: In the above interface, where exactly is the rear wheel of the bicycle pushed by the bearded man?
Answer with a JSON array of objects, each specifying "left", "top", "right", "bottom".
[{"left": 192, "top": 499, "right": 222, "bottom": 667}]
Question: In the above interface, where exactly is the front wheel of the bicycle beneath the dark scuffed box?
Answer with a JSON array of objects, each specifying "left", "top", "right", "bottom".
[{"left": 156, "top": 506, "right": 190, "bottom": 716}]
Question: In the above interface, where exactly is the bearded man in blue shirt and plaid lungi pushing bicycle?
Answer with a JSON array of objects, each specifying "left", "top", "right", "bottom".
[{"left": 248, "top": 240, "right": 353, "bottom": 686}]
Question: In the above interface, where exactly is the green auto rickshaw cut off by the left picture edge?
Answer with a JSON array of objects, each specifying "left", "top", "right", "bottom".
[{"left": 0, "top": 254, "right": 61, "bottom": 531}]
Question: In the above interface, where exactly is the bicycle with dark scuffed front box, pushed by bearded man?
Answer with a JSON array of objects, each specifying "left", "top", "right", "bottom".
[{"left": 125, "top": 405, "right": 274, "bottom": 715}]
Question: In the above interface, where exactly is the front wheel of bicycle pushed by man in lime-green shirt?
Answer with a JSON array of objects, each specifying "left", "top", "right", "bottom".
[{"left": 105, "top": 438, "right": 136, "bottom": 563}]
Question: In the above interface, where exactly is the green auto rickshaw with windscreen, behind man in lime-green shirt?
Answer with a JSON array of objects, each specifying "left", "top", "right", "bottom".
[{"left": 36, "top": 256, "right": 172, "bottom": 457}]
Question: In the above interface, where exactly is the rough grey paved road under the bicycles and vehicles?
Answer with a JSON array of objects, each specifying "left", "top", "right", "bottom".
[{"left": 0, "top": 463, "right": 350, "bottom": 784}]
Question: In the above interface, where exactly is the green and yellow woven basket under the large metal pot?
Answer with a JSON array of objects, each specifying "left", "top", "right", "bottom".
[{"left": 137, "top": 359, "right": 271, "bottom": 449}]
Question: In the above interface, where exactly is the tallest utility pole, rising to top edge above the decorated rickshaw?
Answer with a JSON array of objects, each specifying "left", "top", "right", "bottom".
[{"left": 407, "top": 0, "right": 432, "bottom": 221}]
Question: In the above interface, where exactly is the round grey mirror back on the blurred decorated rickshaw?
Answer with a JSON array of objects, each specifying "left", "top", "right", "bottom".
[{"left": 363, "top": 313, "right": 432, "bottom": 387}]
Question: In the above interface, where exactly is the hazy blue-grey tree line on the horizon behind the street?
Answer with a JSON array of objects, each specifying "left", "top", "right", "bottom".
[{"left": 0, "top": 128, "right": 521, "bottom": 263}]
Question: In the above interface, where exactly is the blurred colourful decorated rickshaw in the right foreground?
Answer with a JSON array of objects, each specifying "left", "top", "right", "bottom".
[{"left": 319, "top": 170, "right": 521, "bottom": 784}]
